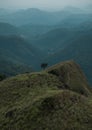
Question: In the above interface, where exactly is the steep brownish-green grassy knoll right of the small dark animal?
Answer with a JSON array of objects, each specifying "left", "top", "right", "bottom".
[{"left": 47, "top": 61, "right": 89, "bottom": 95}]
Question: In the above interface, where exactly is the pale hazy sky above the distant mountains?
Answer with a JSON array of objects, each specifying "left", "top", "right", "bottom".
[{"left": 0, "top": 0, "right": 92, "bottom": 9}]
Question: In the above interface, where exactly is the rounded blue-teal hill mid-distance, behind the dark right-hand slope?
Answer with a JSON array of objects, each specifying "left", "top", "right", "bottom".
[{"left": 32, "top": 27, "right": 76, "bottom": 52}]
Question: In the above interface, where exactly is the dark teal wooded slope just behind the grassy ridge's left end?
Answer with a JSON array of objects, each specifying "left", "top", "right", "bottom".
[{"left": 0, "top": 58, "right": 34, "bottom": 77}]
